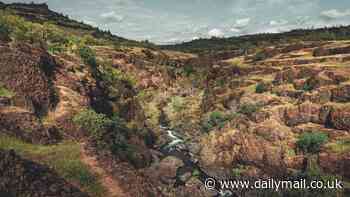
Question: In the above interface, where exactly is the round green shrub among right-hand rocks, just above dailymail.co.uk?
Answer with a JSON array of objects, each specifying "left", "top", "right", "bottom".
[{"left": 297, "top": 133, "right": 328, "bottom": 153}]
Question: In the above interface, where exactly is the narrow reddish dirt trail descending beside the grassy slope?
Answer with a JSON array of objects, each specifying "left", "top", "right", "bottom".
[{"left": 81, "top": 145, "right": 130, "bottom": 197}]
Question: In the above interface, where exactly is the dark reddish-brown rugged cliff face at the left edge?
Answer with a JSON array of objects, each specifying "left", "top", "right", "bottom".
[{"left": 0, "top": 44, "right": 57, "bottom": 115}]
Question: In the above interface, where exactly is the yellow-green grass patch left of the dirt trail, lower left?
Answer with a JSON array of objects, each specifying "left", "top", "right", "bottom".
[{"left": 0, "top": 135, "right": 105, "bottom": 197}]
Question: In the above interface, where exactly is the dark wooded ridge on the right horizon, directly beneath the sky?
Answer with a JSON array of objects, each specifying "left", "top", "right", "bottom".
[{"left": 160, "top": 26, "right": 350, "bottom": 53}]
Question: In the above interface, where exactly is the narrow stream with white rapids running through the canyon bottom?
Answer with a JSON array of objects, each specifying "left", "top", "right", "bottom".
[{"left": 160, "top": 125, "right": 238, "bottom": 197}]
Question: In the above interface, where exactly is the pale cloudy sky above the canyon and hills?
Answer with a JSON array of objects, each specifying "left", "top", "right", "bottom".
[{"left": 0, "top": 0, "right": 350, "bottom": 44}]
